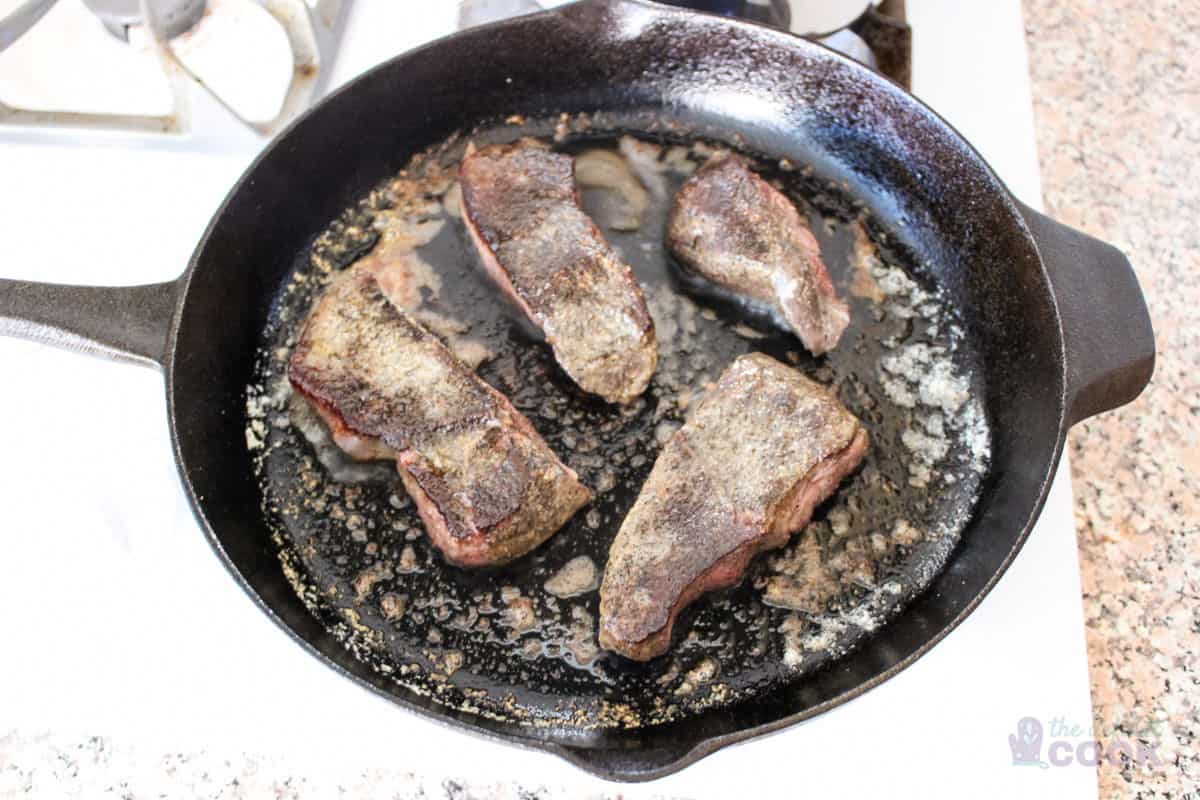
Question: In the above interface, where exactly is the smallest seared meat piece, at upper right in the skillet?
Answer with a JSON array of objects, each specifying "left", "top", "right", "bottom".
[{"left": 667, "top": 154, "right": 850, "bottom": 355}]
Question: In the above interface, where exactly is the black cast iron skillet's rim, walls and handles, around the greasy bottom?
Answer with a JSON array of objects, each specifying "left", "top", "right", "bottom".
[{"left": 0, "top": 0, "right": 1154, "bottom": 781}]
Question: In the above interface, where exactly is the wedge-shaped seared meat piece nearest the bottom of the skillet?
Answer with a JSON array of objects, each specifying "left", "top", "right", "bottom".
[{"left": 600, "top": 354, "right": 868, "bottom": 661}]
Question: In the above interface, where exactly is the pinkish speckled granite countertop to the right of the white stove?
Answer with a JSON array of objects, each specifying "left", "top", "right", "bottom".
[{"left": 1025, "top": 0, "right": 1200, "bottom": 798}]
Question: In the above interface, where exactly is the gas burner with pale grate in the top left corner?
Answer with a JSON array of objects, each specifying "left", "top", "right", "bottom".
[{"left": 0, "top": 0, "right": 349, "bottom": 139}]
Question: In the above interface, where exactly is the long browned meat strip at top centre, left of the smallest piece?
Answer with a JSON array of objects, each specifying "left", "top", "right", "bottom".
[{"left": 460, "top": 140, "right": 658, "bottom": 403}]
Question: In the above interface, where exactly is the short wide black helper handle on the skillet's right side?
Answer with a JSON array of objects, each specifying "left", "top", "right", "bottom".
[{"left": 1019, "top": 204, "right": 1154, "bottom": 425}]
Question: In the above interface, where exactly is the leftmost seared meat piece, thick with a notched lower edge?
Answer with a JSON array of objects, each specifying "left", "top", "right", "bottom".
[{"left": 289, "top": 267, "right": 590, "bottom": 566}]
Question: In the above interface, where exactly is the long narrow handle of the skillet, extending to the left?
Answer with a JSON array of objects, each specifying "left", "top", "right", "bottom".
[{"left": 0, "top": 279, "right": 179, "bottom": 366}]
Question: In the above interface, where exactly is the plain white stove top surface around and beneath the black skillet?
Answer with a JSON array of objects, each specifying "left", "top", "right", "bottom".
[{"left": 0, "top": 0, "right": 1096, "bottom": 798}]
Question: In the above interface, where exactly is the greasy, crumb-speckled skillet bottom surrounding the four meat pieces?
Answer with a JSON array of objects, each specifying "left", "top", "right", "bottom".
[{"left": 246, "top": 126, "right": 989, "bottom": 729}]
